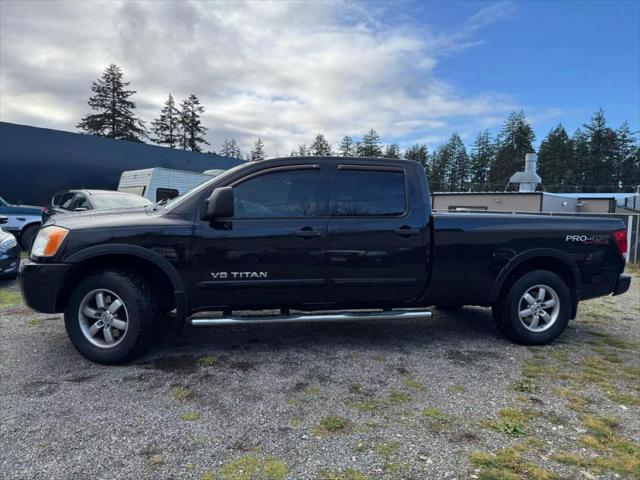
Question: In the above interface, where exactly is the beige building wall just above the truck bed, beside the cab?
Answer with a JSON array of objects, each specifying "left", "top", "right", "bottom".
[{"left": 432, "top": 192, "right": 542, "bottom": 212}]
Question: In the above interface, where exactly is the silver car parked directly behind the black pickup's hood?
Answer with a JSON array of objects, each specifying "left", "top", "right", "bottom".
[{"left": 42, "top": 190, "right": 151, "bottom": 223}]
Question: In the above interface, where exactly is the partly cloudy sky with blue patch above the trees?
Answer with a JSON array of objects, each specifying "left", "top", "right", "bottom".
[{"left": 0, "top": 0, "right": 640, "bottom": 156}]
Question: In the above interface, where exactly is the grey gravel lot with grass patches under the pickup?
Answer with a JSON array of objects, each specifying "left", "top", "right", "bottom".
[{"left": 0, "top": 275, "right": 640, "bottom": 480}]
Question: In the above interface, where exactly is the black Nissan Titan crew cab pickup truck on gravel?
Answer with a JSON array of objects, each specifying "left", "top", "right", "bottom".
[{"left": 20, "top": 157, "right": 630, "bottom": 363}]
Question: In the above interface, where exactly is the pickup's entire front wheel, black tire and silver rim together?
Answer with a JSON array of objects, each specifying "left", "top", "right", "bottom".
[{"left": 64, "top": 270, "right": 160, "bottom": 364}]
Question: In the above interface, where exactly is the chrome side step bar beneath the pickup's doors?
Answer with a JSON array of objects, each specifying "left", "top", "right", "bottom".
[{"left": 189, "top": 310, "right": 431, "bottom": 327}]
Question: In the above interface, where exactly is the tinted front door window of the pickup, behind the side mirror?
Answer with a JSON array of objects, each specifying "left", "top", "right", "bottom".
[{"left": 233, "top": 169, "right": 320, "bottom": 218}]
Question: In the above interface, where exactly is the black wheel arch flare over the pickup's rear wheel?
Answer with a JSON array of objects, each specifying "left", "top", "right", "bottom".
[{"left": 490, "top": 249, "right": 582, "bottom": 318}]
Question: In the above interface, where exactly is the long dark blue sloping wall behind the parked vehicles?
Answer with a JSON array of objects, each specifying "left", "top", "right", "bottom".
[{"left": 0, "top": 122, "right": 242, "bottom": 205}]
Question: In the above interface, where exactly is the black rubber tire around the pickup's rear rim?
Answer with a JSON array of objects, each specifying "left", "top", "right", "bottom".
[{"left": 492, "top": 270, "right": 571, "bottom": 345}]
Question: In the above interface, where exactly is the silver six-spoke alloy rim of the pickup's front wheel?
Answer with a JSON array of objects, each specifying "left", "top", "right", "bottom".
[{"left": 78, "top": 288, "right": 129, "bottom": 348}]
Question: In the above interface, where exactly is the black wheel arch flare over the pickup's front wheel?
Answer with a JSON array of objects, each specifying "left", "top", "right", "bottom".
[{"left": 56, "top": 244, "right": 188, "bottom": 319}]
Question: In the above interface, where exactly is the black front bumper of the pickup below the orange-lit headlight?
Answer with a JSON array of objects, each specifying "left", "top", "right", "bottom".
[{"left": 18, "top": 258, "right": 69, "bottom": 313}]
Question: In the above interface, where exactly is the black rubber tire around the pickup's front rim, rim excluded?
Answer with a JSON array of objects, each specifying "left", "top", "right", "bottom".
[{"left": 64, "top": 270, "right": 160, "bottom": 364}]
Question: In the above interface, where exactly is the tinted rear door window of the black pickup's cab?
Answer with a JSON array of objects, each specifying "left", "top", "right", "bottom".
[{"left": 330, "top": 170, "right": 406, "bottom": 217}]
